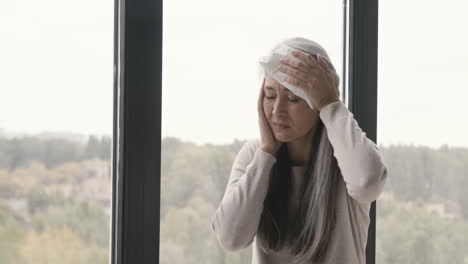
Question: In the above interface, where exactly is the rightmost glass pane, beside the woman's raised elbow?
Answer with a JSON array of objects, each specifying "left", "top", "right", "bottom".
[{"left": 376, "top": 0, "right": 468, "bottom": 264}]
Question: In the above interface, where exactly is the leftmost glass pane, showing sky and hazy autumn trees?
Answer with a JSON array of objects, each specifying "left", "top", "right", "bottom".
[{"left": 0, "top": 0, "right": 114, "bottom": 264}]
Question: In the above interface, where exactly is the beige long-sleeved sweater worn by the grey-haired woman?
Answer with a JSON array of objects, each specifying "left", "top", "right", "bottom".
[{"left": 211, "top": 102, "right": 387, "bottom": 264}]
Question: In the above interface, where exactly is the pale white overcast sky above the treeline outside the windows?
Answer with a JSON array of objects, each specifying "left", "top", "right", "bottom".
[{"left": 0, "top": 0, "right": 468, "bottom": 148}]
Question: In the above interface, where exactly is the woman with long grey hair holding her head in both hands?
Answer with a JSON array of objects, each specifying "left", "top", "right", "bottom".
[{"left": 211, "top": 38, "right": 387, "bottom": 264}]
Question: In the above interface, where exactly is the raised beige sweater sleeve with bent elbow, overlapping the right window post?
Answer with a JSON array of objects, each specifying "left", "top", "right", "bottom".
[{"left": 319, "top": 101, "right": 387, "bottom": 203}]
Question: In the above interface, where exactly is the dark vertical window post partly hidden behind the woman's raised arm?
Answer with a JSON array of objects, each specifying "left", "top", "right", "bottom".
[{"left": 343, "top": 0, "right": 379, "bottom": 264}]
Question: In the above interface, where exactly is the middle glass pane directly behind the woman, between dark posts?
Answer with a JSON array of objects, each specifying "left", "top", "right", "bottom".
[{"left": 160, "top": 0, "right": 343, "bottom": 264}]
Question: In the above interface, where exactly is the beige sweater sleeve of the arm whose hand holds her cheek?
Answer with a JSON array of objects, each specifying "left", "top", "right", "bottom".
[{"left": 211, "top": 139, "right": 276, "bottom": 251}]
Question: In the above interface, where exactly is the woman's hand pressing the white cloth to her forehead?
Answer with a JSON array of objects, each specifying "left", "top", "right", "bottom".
[{"left": 279, "top": 51, "right": 340, "bottom": 111}]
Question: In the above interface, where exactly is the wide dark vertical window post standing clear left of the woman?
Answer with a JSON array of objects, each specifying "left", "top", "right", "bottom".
[{"left": 109, "top": 0, "right": 163, "bottom": 264}]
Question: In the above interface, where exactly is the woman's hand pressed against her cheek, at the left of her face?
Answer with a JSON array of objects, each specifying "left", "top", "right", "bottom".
[{"left": 257, "top": 78, "right": 283, "bottom": 155}]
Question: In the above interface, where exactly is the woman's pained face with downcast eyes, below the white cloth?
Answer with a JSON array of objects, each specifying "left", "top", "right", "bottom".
[{"left": 263, "top": 74, "right": 319, "bottom": 142}]
